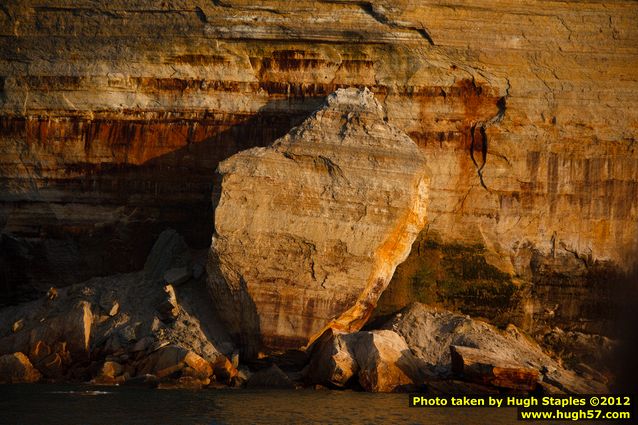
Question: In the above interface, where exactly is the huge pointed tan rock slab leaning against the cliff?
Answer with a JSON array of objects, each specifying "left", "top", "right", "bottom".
[{"left": 208, "top": 88, "right": 428, "bottom": 357}]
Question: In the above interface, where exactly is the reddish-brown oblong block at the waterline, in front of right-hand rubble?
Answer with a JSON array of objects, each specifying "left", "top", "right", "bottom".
[{"left": 450, "top": 345, "right": 540, "bottom": 391}]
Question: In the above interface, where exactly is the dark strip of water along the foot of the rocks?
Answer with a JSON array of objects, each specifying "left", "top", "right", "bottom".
[{"left": 0, "top": 384, "right": 576, "bottom": 425}]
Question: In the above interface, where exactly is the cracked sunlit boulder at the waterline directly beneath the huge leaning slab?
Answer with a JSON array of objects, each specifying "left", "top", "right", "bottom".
[{"left": 307, "top": 330, "right": 425, "bottom": 392}]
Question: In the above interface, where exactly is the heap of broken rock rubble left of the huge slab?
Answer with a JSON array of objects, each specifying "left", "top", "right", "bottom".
[{"left": 0, "top": 231, "right": 237, "bottom": 388}]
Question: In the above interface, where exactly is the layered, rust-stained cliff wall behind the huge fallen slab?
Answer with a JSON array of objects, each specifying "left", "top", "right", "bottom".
[{"left": 0, "top": 0, "right": 638, "bottom": 330}]
